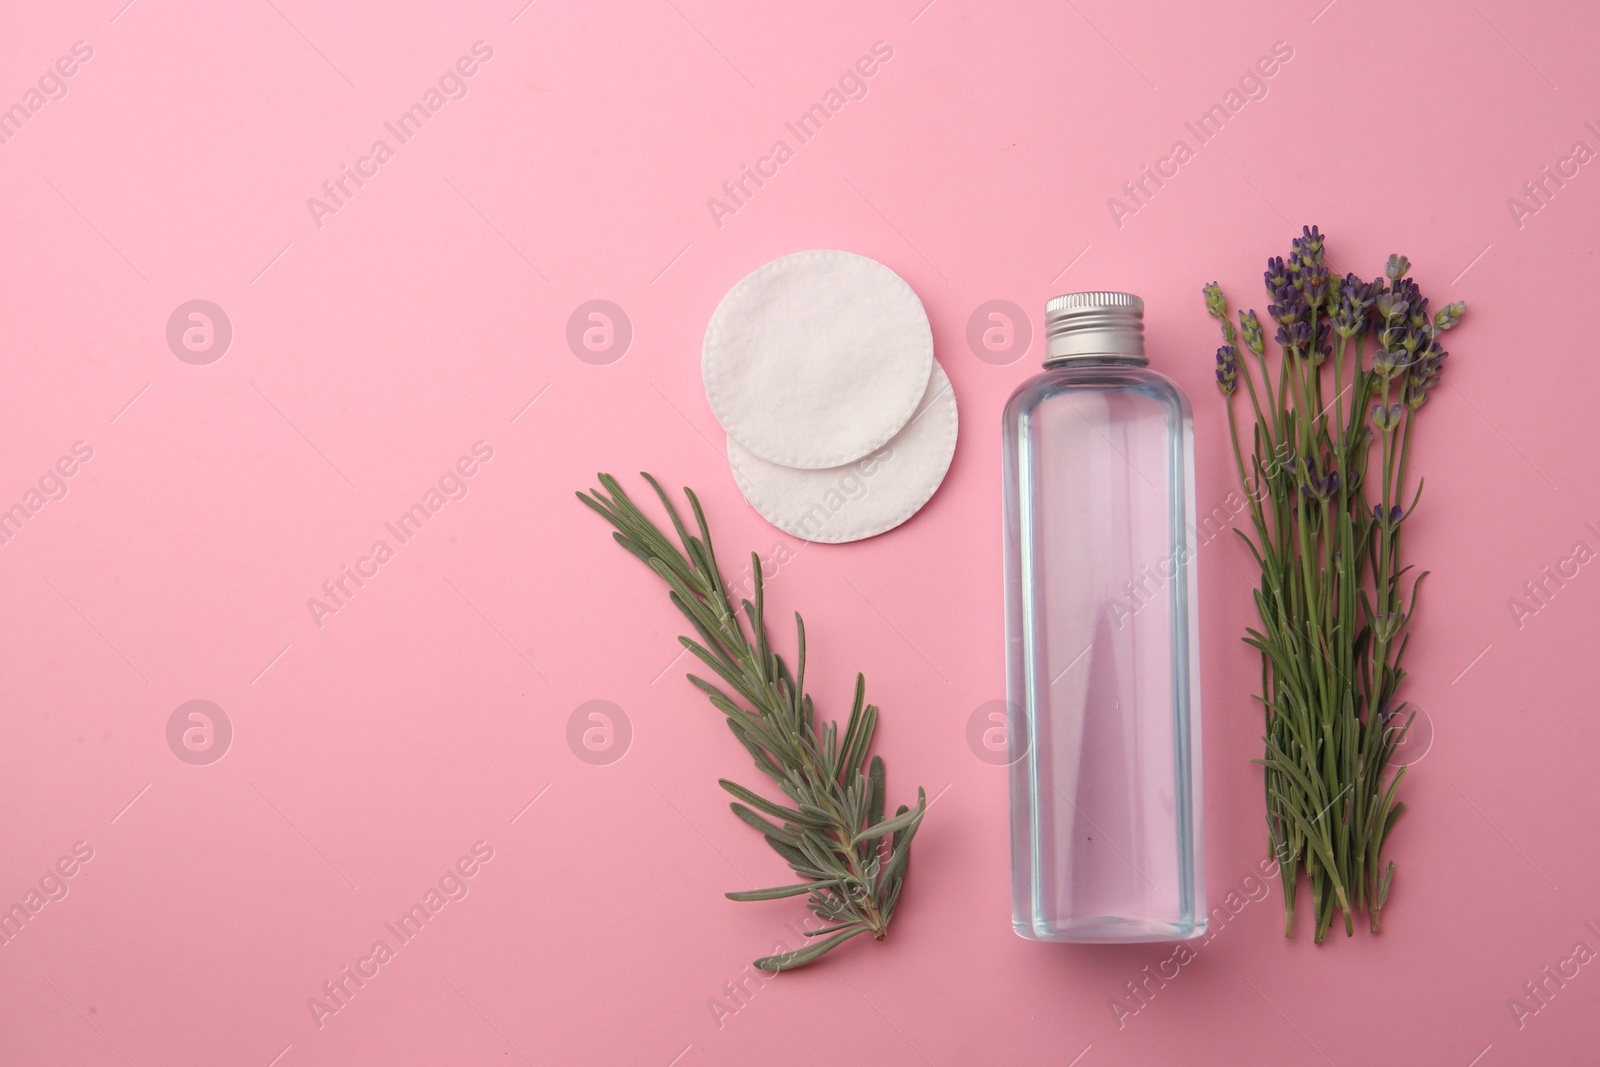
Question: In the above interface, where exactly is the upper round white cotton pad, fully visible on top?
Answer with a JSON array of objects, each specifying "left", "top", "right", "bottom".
[{"left": 701, "top": 251, "right": 933, "bottom": 469}]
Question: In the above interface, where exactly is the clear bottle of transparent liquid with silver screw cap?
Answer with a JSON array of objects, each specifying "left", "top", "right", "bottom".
[{"left": 1003, "top": 293, "right": 1206, "bottom": 942}]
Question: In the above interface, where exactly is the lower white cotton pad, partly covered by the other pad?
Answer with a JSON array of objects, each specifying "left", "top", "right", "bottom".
[{"left": 728, "top": 363, "right": 955, "bottom": 544}]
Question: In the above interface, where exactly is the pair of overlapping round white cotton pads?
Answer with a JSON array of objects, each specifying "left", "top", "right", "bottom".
[{"left": 701, "top": 251, "right": 957, "bottom": 544}]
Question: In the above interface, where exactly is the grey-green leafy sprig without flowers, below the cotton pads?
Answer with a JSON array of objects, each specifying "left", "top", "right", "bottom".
[{"left": 578, "top": 474, "right": 928, "bottom": 971}]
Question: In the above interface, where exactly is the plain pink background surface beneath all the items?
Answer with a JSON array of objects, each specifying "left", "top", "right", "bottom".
[{"left": 0, "top": 0, "right": 1600, "bottom": 1067}]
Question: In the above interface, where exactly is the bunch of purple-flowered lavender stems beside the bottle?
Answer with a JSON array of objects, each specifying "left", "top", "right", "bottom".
[{"left": 1203, "top": 227, "right": 1466, "bottom": 944}]
